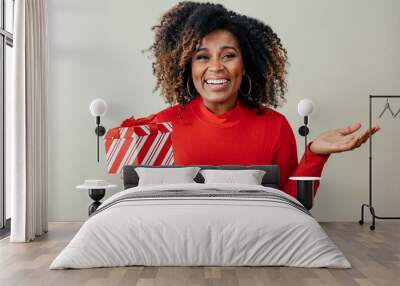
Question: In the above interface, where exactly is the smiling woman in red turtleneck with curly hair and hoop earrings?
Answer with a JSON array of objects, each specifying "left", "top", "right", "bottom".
[{"left": 139, "top": 2, "right": 379, "bottom": 199}]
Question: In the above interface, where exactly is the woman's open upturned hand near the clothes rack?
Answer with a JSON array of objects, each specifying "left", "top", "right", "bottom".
[{"left": 310, "top": 123, "right": 381, "bottom": 155}]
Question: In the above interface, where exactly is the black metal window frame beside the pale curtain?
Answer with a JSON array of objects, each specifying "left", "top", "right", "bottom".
[{"left": 0, "top": 0, "right": 15, "bottom": 232}]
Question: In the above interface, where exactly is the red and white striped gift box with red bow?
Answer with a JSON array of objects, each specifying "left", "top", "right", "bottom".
[{"left": 104, "top": 117, "right": 174, "bottom": 173}]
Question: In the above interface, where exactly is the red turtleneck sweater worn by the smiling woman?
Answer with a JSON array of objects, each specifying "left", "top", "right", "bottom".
[{"left": 142, "top": 96, "right": 329, "bottom": 197}]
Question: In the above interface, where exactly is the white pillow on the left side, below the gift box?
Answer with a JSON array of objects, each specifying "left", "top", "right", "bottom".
[{"left": 135, "top": 167, "right": 200, "bottom": 186}]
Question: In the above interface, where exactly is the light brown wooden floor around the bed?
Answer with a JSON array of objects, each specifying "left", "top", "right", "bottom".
[{"left": 0, "top": 221, "right": 400, "bottom": 286}]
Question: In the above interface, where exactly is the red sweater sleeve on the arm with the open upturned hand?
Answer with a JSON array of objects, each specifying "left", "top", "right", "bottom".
[{"left": 273, "top": 117, "right": 329, "bottom": 197}]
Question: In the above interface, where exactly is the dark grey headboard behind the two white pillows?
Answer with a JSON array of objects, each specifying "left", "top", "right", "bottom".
[{"left": 123, "top": 165, "right": 279, "bottom": 189}]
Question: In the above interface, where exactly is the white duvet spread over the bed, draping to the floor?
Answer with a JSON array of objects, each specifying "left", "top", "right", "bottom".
[{"left": 50, "top": 183, "right": 351, "bottom": 269}]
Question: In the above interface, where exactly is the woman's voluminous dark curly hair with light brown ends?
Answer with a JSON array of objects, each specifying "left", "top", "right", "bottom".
[{"left": 149, "top": 2, "right": 287, "bottom": 113}]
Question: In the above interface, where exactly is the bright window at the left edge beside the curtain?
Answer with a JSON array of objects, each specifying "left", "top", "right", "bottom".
[{"left": 0, "top": 0, "right": 14, "bottom": 236}]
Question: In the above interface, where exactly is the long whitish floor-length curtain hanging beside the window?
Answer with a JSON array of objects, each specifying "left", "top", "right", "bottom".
[{"left": 6, "top": 0, "right": 48, "bottom": 242}]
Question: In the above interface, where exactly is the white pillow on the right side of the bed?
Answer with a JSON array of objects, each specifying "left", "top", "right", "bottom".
[{"left": 200, "top": 169, "right": 266, "bottom": 185}]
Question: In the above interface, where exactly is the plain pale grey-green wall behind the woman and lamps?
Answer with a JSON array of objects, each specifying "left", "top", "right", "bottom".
[{"left": 48, "top": 0, "right": 400, "bottom": 221}]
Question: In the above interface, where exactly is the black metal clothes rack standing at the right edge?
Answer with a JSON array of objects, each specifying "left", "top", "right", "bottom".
[{"left": 359, "top": 95, "right": 400, "bottom": 230}]
